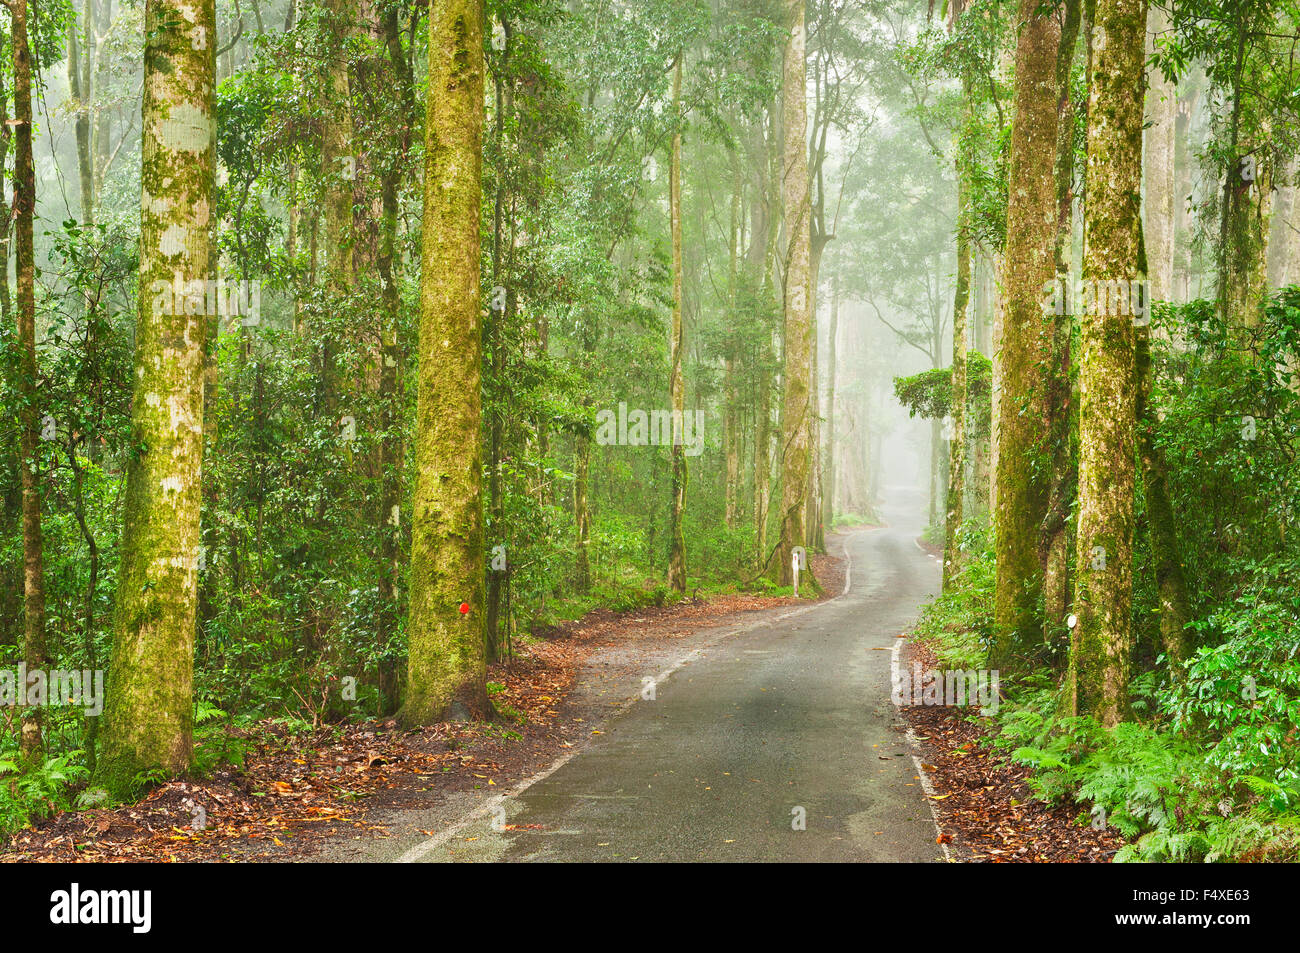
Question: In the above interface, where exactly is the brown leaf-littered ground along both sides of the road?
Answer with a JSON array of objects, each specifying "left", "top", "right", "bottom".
[{"left": 0, "top": 525, "right": 1121, "bottom": 862}]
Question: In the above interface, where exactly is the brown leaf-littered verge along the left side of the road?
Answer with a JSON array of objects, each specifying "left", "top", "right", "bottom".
[{"left": 0, "top": 546, "right": 844, "bottom": 862}]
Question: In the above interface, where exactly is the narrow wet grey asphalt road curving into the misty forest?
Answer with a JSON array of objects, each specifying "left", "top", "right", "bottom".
[{"left": 400, "top": 501, "right": 944, "bottom": 862}]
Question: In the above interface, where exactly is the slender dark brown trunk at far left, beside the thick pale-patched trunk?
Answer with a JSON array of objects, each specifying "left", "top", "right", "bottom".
[{"left": 5, "top": 0, "right": 46, "bottom": 758}]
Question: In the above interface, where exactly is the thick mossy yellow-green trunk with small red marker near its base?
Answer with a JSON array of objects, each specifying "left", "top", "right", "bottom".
[{"left": 403, "top": 0, "right": 490, "bottom": 724}]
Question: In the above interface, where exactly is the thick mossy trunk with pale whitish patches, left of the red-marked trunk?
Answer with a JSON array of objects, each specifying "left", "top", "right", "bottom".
[{"left": 98, "top": 0, "right": 217, "bottom": 794}]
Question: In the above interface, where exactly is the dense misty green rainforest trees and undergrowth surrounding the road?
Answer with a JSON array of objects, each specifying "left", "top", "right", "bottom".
[{"left": 0, "top": 0, "right": 1300, "bottom": 859}]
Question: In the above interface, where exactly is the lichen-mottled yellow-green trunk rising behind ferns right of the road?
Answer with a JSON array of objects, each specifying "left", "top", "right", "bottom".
[{"left": 1070, "top": 0, "right": 1147, "bottom": 727}]
